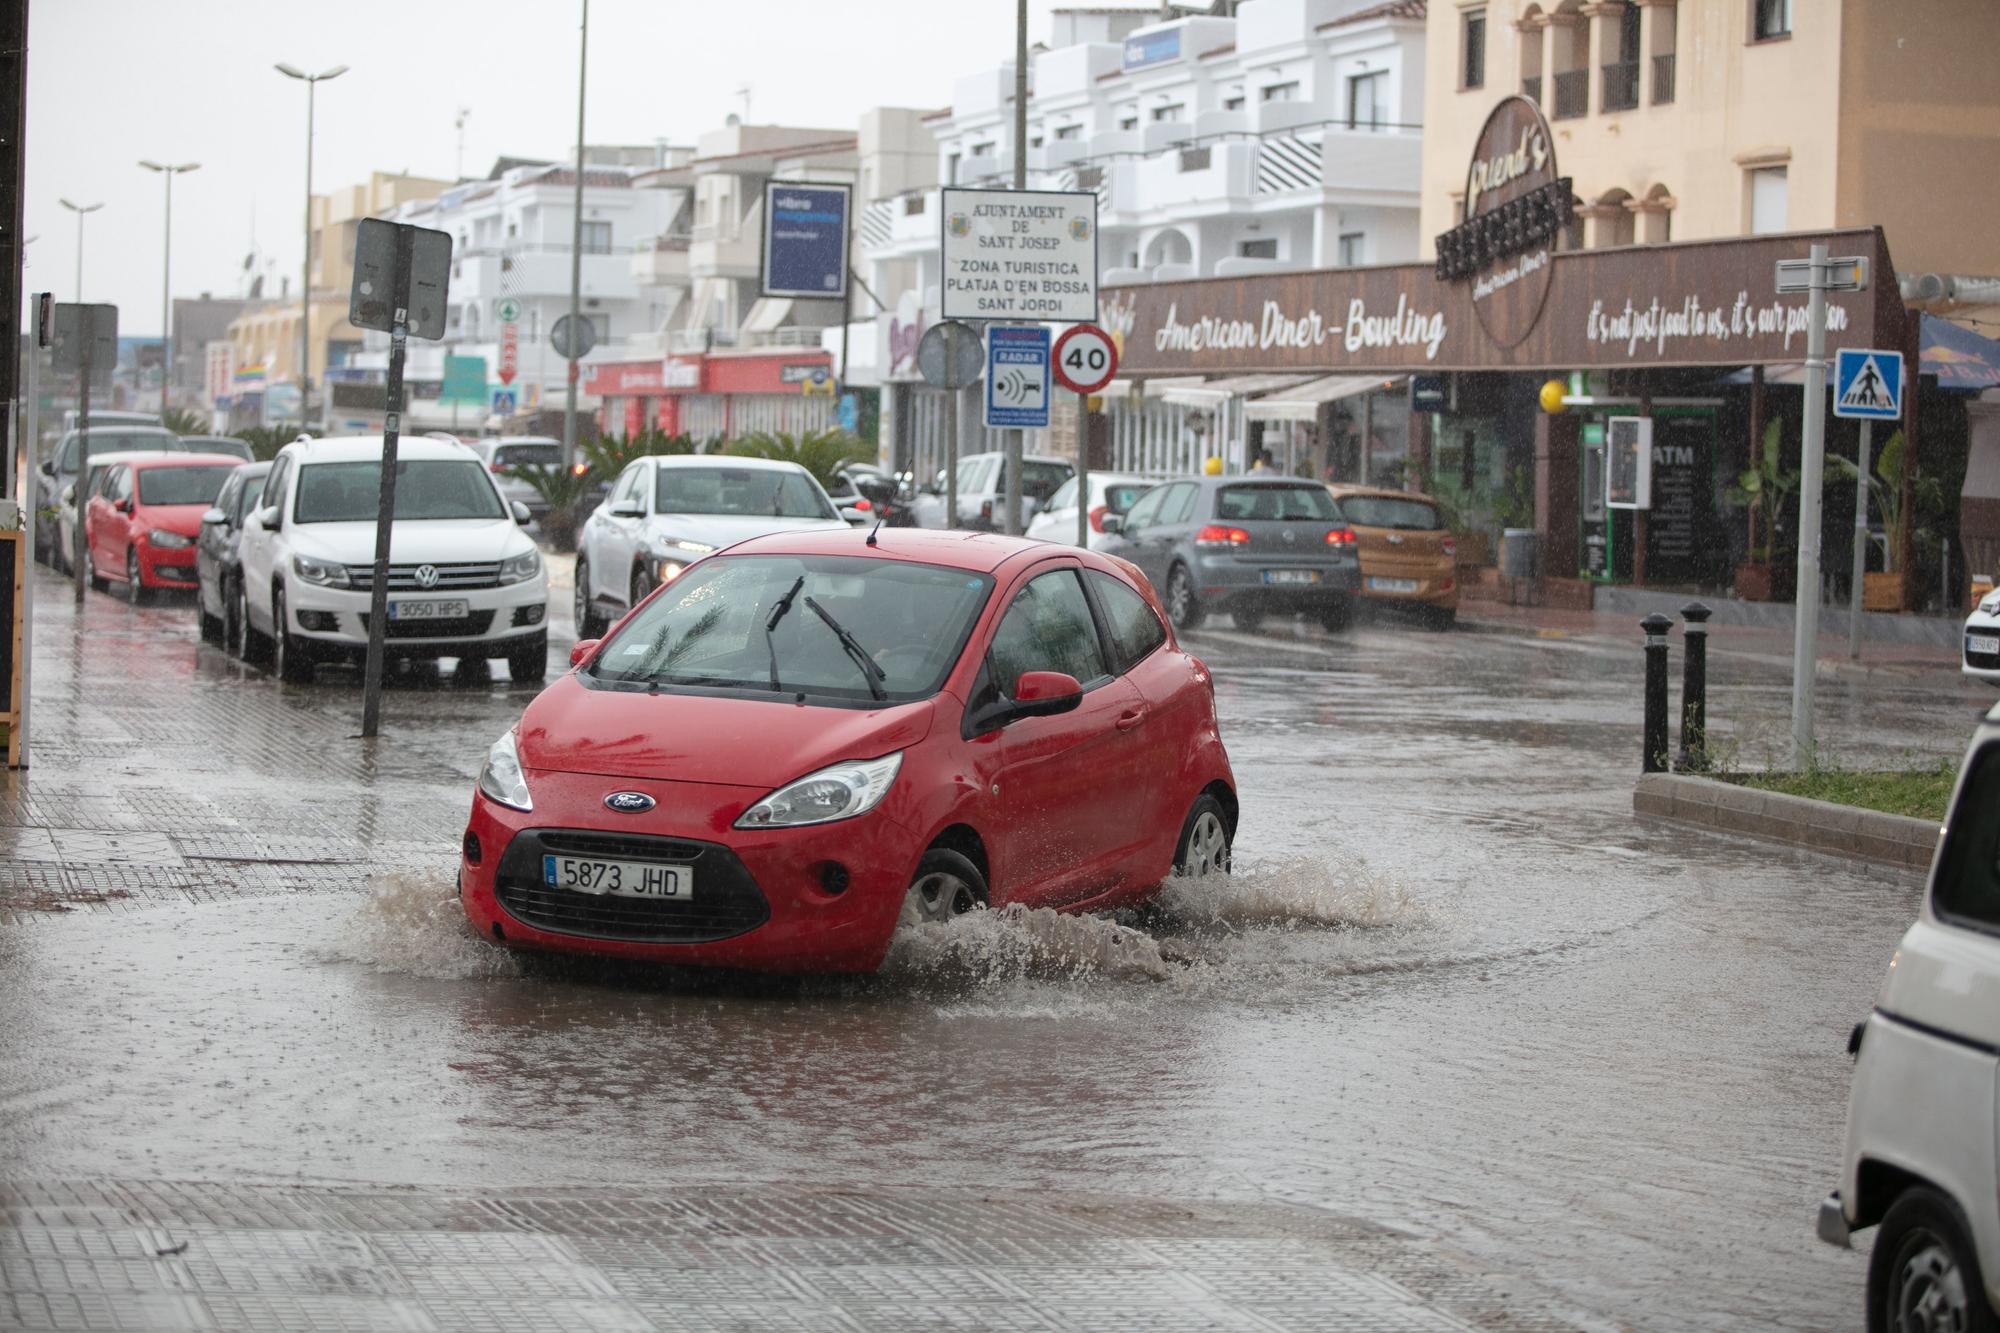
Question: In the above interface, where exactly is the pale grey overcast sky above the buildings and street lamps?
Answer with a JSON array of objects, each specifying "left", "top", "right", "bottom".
[{"left": 26, "top": 0, "right": 1080, "bottom": 336}]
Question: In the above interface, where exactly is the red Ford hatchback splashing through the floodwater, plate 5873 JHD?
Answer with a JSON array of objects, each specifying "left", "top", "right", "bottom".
[{"left": 458, "top": 528, "right": 1236, "bottom": 971}]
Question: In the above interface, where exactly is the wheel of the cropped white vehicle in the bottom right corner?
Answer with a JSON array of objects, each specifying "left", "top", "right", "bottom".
[{"left": 1868, "top": 1185, "right": 2000, "bottom": 1333}]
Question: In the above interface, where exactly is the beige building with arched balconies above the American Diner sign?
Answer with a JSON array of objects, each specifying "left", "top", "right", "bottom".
[{"left": 1422, "top": 0, "right": 2000, "bottom": 274}]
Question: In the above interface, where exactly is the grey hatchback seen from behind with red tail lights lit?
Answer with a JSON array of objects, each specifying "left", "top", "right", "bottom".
[{"left": 1100, "top": 476, "right": 1362, "bottom": 628}]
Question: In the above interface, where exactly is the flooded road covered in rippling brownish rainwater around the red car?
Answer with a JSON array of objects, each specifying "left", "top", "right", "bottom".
[{"left": 0, "top": 564, "right": 1990, "bottom": 1329}]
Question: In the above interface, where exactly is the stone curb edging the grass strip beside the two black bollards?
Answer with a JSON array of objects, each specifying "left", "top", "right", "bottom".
[{"left": 1632, "top": 773, "right": 1940, "bottom": 871}]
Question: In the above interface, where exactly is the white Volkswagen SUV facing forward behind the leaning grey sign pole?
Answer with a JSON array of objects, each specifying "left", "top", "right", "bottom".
[{"left": 236, "top": 434, "right": 548, "bottom": 681}]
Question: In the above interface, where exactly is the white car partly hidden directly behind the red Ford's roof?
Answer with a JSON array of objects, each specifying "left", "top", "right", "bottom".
[{"left": 576, "top": 454, "right": 848, "bottom": 638}]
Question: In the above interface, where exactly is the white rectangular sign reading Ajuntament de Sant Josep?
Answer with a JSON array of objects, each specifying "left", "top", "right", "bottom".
[{"left": 938, "top": 188, "right": 1098, "bottom": 324}]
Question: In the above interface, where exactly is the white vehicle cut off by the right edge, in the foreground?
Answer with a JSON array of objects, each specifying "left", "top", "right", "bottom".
[{"left": 1820, "top": 709, "right": 2000, "bottom": 1333}]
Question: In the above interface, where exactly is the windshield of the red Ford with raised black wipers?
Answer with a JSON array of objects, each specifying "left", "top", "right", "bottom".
[{"left": 588, "top": 556, "right": 992, "bottom": 705}]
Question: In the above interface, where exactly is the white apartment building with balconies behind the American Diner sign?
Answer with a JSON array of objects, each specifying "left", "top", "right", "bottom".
[{"left": 862, "top": 0, "right": 1426, "bottom": 476}]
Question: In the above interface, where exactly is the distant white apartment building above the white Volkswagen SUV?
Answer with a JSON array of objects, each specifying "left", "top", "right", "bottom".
[{"left": 332, "top": 153, "right": 688, "bottom": 432}]
